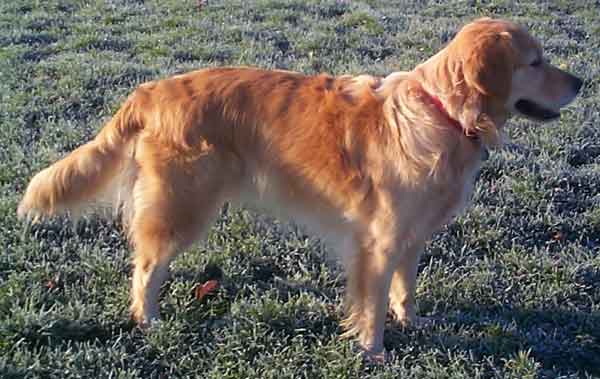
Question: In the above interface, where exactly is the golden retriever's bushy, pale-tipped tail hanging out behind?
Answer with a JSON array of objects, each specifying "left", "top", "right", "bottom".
[{"left": 17, "top": 93, "right": 144, "bottom": 221}]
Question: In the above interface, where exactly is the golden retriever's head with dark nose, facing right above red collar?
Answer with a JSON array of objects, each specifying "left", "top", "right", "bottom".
[{"left": 422, "top": 18, "right": 583, "bottom": 145}]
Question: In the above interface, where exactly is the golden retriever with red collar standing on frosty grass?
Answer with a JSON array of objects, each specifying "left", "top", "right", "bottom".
[{"left": 18, "top": 18, "right": 582, "bottom": 359}]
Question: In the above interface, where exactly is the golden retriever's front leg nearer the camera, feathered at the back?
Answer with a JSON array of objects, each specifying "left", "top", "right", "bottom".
[{"left": 343, "top": 235, "right": 397, "bottom": 361}]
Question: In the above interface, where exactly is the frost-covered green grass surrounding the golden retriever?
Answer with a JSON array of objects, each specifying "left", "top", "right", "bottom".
[{"left": 0, "top": 0, "right": 600, "bottom": 378}]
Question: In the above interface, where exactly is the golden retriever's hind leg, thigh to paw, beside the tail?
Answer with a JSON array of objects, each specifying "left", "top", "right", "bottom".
[{"left": 130, "top": 148, "right": 229, "bottom": 326}]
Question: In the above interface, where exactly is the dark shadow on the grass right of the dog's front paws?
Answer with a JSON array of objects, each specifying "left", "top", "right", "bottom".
[{"left": 385, "top": 307, "right": 600, "bottom": 375}]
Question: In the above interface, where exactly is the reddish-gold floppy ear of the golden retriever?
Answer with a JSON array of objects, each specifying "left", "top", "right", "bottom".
[{"left": 462, "top": 32, "right": 515, "bottom": 100}]
